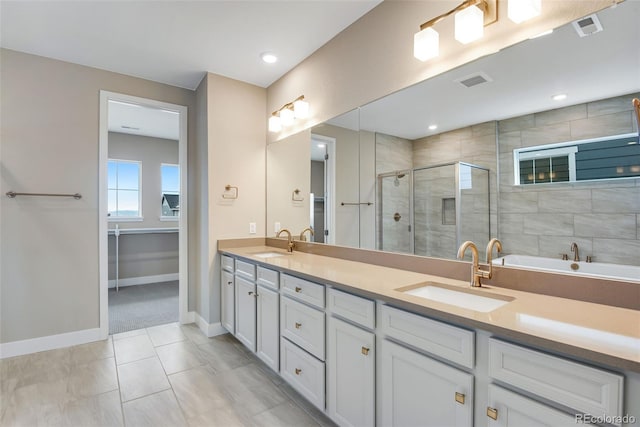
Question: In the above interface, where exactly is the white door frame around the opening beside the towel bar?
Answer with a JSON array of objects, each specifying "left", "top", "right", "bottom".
[{"left": 98, "top": 90, "right": 189, "bottom": 339}]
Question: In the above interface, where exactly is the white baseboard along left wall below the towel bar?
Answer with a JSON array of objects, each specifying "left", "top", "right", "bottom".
[{"left": 0, "top": 328, "right": 100, "bottom": 359}]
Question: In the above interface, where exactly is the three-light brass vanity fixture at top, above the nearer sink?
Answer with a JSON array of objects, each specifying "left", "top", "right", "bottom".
[{"left": 413, "top": 0, "right": 542, "bottom": 62}]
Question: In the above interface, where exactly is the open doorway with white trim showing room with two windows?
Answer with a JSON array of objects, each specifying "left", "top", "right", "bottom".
[{"left": 98, "top": 91, "right": 188, "bottom": 339}]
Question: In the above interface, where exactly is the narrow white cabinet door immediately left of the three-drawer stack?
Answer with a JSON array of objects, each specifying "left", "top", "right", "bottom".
[{"left": 257, "top": 285, "right": 280, "bottom": 372}]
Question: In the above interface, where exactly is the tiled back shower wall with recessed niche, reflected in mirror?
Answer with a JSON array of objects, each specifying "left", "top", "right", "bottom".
[{"left": 413, "top": 121, "right": 498, "bottom": 258}]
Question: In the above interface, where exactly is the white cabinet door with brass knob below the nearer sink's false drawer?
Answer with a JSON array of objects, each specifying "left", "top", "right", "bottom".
[{"left": 377, "top": 340, "right": 473, "bottom": 427}]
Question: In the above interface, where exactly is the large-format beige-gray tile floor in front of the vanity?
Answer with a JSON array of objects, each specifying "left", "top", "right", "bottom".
[{"left": 0, "top": 323, "right": 334, "bottom": 427}]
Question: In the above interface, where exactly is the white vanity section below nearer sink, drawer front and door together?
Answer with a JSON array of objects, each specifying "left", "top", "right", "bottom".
[{"left": 377, "top": 305, "right": 474, "bottom": 427}]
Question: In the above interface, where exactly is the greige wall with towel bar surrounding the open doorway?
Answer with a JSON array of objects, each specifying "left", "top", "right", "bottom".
[{"left": 0, "top": 49, "right": 198, "bottom": 343}]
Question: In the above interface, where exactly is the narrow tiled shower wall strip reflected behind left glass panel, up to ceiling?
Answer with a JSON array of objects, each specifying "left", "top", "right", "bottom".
[{"left": 375, "top": 133, "right": 413, "bottom": 253}]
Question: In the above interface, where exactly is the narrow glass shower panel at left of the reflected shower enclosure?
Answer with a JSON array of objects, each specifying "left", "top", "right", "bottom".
[{"left": 377, "top": 170, "right": 413, "bottom": 254}]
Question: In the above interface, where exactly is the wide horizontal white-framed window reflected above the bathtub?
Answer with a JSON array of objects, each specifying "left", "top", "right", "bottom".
[{"left": 513, "top": 134, "right": 640, "bottom": 185}]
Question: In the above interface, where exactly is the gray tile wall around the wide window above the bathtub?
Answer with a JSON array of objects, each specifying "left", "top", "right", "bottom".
[{"left": 498, "top": 93, "right": 640, "bottom": 265}]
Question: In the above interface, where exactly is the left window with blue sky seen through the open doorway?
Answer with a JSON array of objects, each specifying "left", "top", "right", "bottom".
[{"left": 107, "top": 159, "right": 142, "bottom": 219}]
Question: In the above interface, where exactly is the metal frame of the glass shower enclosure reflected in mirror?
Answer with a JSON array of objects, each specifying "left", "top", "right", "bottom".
[{"left": 376, "top": 162, "right": 491, "bottom": 254}]
